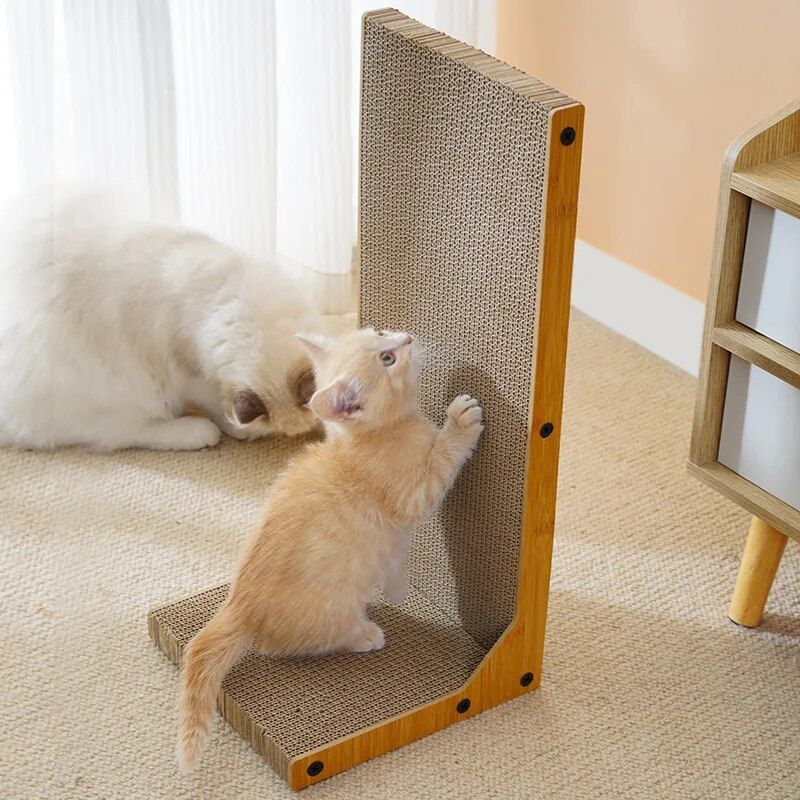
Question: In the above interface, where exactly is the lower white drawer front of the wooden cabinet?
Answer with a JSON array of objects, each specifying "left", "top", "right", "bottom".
[{"left": 719, "top": 356, "right": 800, "bottom": 510}]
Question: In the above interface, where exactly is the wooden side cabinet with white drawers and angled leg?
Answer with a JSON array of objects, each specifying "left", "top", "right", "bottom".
[{"left": 689, "top": 99, "right": 800, "bottom": 627}]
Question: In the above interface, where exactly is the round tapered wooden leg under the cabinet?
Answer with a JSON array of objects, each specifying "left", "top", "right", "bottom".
[{"left": 728, "top": 517, "right": 789, "bottom": 628}]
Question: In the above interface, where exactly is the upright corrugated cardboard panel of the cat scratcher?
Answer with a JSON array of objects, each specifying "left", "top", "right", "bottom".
[{"left": 360, "top": 11, "right": 573, "bottom": 647}]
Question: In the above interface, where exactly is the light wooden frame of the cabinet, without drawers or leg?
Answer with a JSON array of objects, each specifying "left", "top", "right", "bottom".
[{"left": 688, "top": 98, "right": 800, "bottom": 539}]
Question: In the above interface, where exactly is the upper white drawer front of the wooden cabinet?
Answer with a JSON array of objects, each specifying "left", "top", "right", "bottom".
[{"left": 736, "top": 200, "right": 800, "bottom": 353}]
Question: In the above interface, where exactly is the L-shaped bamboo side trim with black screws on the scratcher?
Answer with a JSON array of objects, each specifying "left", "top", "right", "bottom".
[{"left": 289, "top": 103, "right": 584, "bottom": 789}]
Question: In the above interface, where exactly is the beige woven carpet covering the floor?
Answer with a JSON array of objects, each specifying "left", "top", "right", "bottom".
[{"left": 0, "top": 315, "right": 800, "bottom": 800}]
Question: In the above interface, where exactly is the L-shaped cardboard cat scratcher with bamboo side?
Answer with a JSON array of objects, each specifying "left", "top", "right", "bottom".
[{"left": 149, "top": 10, "right": 583, "bottom": 789}]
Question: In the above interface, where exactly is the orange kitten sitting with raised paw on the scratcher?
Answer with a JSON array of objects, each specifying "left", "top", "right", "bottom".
[{"left": 178, "top": 328, "right": 483, "bottom": 769}]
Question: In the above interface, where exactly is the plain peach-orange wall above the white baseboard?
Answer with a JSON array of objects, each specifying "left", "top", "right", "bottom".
[{"left": 497, "top": 0, "right": 800, "bottom": 299}]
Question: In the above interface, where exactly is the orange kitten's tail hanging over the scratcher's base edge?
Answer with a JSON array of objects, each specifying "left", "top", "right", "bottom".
[{"left": 178, "top": 606, "right": 251, "bottom": 772}]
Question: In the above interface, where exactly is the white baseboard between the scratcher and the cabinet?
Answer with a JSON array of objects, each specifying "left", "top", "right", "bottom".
[{"left": 572, "top": 239, "right": 705, "bottom": 375}]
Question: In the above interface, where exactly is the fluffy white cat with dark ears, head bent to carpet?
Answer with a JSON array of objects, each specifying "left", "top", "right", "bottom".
[{"left": 0, "top": 191, "right": 320, "bottom": 450}]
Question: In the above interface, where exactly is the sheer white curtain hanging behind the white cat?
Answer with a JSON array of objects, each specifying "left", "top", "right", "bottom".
[{"left": 0, "top": 0, "right": 495, "bottom": 312}]
